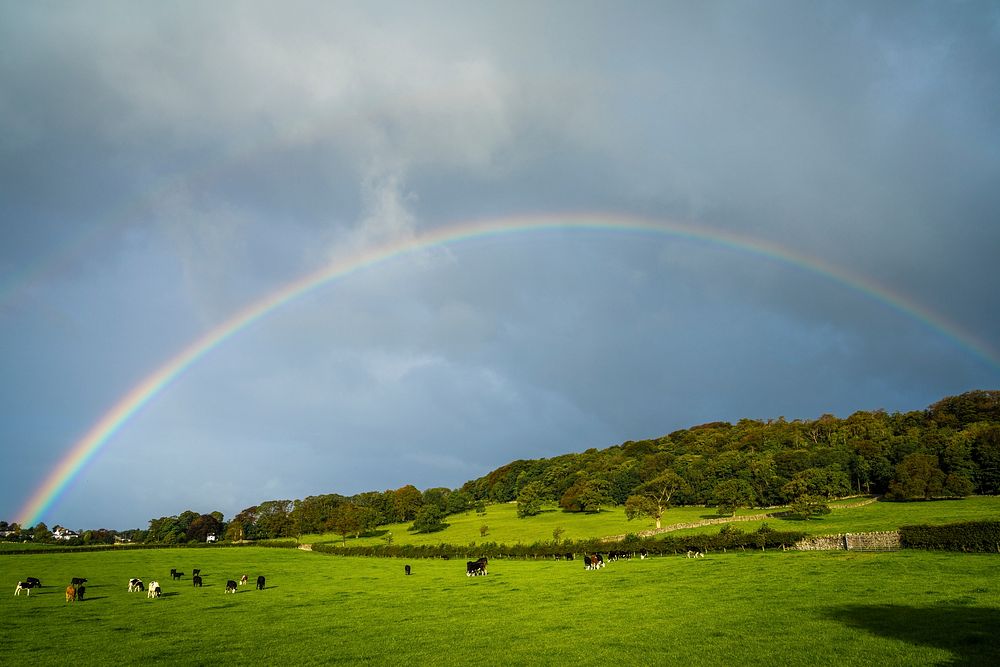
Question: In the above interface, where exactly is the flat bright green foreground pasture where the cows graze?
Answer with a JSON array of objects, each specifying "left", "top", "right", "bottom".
[{"left": 0, "top": 547, "right": 1000, "bottom": 665}]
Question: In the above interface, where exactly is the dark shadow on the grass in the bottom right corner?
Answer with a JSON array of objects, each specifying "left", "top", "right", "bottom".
[{"left": 826, "top": 604, "right": 1000, "bottom": 665}]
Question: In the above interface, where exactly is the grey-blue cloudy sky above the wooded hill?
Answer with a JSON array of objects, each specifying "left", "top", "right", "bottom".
[{"left": 0, "top": 1, "right": 1000, "bottom": 529}]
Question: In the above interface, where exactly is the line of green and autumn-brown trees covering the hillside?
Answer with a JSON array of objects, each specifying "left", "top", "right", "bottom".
[{"left": 5, "top": 391, "right": 1000, "bottom": 544}]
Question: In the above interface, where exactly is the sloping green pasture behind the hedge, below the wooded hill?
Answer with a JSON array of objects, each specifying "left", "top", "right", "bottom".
[{"left": 300, "top": 496, "right": 1000, "bottom": 546}]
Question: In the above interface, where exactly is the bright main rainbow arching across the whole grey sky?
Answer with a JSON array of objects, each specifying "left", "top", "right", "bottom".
[{"left": 17, "top": 213, "right": 1000, "bottom": 526}]
